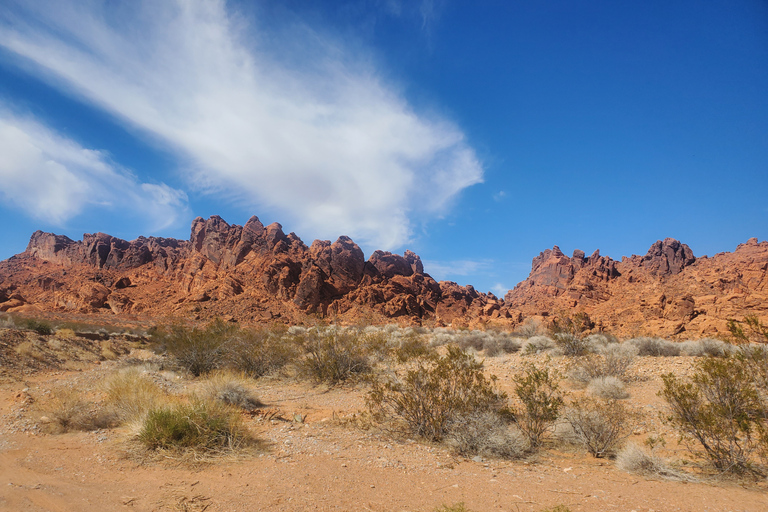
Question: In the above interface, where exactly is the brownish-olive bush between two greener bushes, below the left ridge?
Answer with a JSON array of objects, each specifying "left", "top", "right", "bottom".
[{"left": 221, "top": 329, "right": 299, "bottom": 379}]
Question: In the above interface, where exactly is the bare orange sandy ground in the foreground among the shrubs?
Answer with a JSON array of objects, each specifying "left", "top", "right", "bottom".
[{"left": 0, "top": 336, "right": 768, "bottom": 512}]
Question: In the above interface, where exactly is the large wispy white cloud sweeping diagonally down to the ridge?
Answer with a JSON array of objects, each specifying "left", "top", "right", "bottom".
[{"left": 0, "top": 0, "right": 483, "bottom": 248}]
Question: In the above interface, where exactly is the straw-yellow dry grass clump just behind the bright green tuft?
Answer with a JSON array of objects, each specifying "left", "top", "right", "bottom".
[{"left": 104, "top": 367, "right": 165, "bottom": 421}]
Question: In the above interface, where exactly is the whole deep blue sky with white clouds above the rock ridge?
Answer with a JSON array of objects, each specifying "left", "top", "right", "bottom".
[{"left": 0, "top": 0, "right": 768, "bottom": 294}]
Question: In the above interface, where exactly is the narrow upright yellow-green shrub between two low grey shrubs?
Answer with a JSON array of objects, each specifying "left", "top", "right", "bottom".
[{"left": 515, "top": 365, "right": 564, "bottom": 449}]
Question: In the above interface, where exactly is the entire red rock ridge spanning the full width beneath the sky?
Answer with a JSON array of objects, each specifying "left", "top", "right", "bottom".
[{"left": 0, "top": 216, "right": 768, "bottom": 337}]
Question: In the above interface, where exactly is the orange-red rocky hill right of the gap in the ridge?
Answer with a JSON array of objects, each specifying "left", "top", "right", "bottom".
[{"left": 505, "top": 238, "right": 768, "bottom": 337}]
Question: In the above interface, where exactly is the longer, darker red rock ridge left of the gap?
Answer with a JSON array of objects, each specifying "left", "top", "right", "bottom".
[{"left": 2, "top": 216, "right": 490, "bottom": 322}]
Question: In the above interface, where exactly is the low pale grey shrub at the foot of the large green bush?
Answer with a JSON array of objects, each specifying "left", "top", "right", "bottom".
[{"left": 446, "top": 412, "right": 528, "bottom": 459}]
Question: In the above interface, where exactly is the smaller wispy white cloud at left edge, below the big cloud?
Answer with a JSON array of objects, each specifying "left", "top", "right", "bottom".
[{"left": 0, "top": 110, "right": 187, "bottom": 231}]
